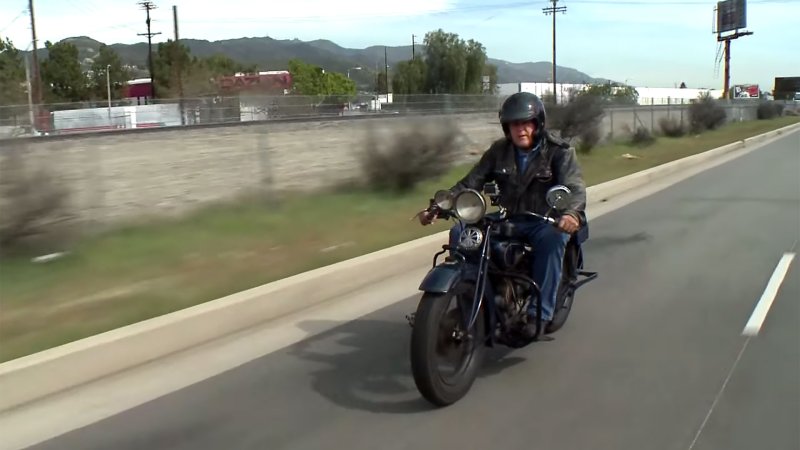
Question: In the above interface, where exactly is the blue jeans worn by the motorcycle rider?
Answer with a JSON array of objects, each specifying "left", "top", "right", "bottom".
[{"left": 450, "top": 219, "right": 570, "bottom": 321}]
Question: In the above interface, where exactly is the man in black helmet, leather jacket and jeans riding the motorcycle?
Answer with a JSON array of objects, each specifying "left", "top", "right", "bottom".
[{"left": 420, "top": 92, "right": 586, "bottom": 336}]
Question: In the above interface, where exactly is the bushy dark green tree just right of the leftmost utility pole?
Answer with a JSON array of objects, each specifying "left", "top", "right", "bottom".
[{"left": 41, "top": 41, "right": 88, "bottom": 103}]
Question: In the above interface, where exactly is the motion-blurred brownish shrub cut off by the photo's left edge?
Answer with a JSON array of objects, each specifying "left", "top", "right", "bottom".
[{"left": 0, "top": 143, "right": 73, "bottom": 250}]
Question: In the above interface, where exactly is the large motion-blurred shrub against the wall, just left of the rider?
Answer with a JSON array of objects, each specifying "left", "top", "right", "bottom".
[{"left": 361, "top": 120, "right": 461, "bottom": 192}]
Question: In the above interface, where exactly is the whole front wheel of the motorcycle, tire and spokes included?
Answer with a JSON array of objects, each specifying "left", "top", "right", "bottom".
[{"left": 411, "top": 283, "right": 486, "bottom": 406}]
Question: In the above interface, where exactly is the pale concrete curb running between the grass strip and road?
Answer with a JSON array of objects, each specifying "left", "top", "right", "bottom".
[{"left": 0, "top": 120, "right": 800, "bottom": 411}]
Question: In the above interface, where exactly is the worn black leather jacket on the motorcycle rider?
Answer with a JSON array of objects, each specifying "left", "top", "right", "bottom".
[{"left": 452, "top": 132, "right": 586, "bottom": 225}]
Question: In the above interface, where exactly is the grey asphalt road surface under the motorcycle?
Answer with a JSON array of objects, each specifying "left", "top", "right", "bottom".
[{"left": 26, "top": 133, "right": 800, "bottom": 450}]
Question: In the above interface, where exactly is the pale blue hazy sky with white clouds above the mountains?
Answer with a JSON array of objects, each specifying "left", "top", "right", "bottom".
[{"left": 0, "top": 0, "right": 800, "bottom": 90}]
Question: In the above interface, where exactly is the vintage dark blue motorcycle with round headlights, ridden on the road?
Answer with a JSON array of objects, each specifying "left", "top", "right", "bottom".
[{"left": 406, "top": 182, "right": 597, "bottom": 406}]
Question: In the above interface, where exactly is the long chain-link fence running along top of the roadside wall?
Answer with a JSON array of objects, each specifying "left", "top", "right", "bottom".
[{"left": 0, "top": 93, "right": 797, "bottom": 138}]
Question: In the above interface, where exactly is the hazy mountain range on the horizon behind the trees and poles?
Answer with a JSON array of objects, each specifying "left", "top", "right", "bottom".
[{"left": 26, "top": 36, "right": 609, "bottom": 85}]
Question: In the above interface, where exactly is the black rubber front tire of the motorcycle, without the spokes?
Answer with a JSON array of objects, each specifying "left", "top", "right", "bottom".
[{"left": 411, "top": 283, "right": 486, "bottom": 407}]
